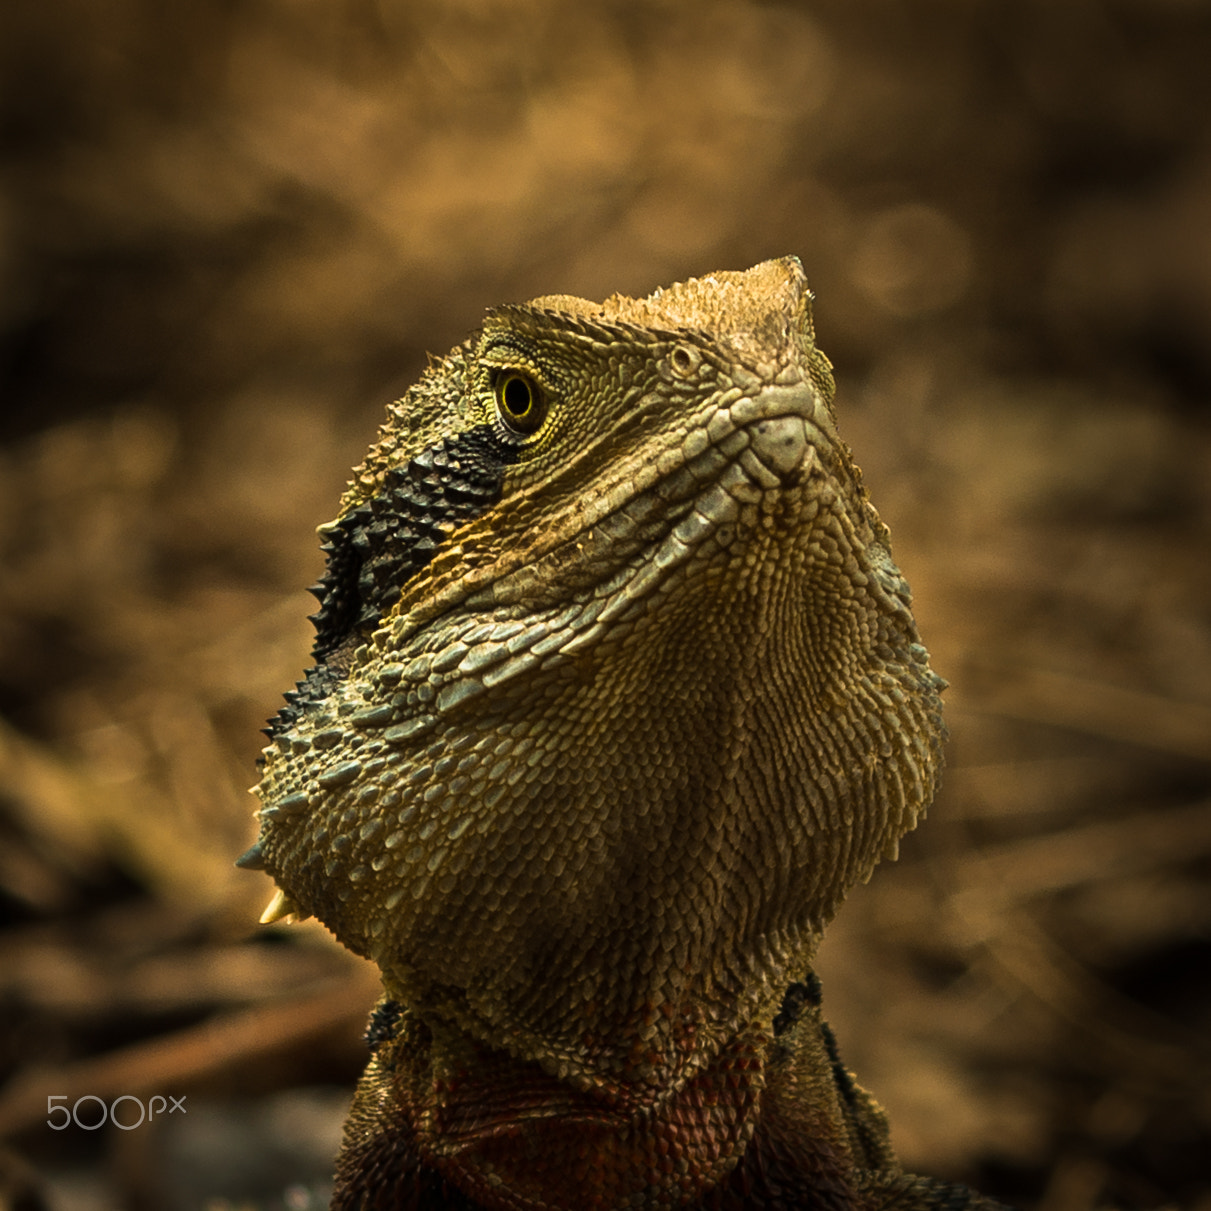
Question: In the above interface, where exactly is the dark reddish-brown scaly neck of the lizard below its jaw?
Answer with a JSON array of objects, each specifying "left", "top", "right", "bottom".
[{"left": 332, "top": 989, "right": 876, "bottom": 1211}]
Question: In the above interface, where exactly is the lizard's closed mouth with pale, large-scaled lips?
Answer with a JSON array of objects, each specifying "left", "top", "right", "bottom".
[{"left": 265, "top": 383, "right": 836, "bottom": 742}]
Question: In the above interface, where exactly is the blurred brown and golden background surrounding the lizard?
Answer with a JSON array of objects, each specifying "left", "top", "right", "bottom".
[{"left": 0, "top": 0, "right": 1211, "bottom": 1211}]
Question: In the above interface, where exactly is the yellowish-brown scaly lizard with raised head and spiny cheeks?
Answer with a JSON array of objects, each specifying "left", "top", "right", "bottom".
[{"left": 239, "top": 257, "right": 995, "bottom": 1211}]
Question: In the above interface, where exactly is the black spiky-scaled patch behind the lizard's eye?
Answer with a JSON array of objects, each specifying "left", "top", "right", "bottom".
[{"left": 266, "top": 425, "right": 520, "bottom": 739}]
